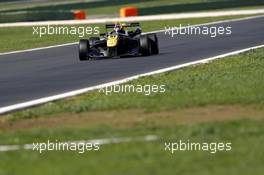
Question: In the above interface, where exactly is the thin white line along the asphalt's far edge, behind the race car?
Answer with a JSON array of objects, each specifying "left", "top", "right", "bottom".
[{"left": 0, "top": 15, "right": 264, "bottom": 56}]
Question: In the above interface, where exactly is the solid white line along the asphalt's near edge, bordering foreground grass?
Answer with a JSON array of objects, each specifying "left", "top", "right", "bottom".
[{"left": 0, "top": 45, "right": 264, "bottom": 114}]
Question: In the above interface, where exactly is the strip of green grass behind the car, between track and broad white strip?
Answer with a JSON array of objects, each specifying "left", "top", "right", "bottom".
[{"left": 0, "top": 16, "right": 260, "bottom": 53}]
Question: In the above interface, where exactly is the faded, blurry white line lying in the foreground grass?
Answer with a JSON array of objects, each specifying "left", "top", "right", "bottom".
[{"left": 0, "top": 135, "right": 158, "bottom": 152}]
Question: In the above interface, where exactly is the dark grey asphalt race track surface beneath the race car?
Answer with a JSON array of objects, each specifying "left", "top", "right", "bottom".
[{"left": 0, "top": 17, "right": 264, "bottom": 107}]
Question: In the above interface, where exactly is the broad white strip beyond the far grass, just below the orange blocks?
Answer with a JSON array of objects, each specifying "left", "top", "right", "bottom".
[{"left": 0, "top": 9, "right": 264, "bottom": 27}]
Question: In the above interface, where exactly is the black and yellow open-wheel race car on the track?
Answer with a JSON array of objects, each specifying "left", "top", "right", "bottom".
[{"left": 79, "top": 23, "right": 159, "bottom": 61}]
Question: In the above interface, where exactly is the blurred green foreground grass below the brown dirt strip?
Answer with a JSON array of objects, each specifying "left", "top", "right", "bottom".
[{"left": 0, "top": 121, "right": 264, "bottom": 175}]
